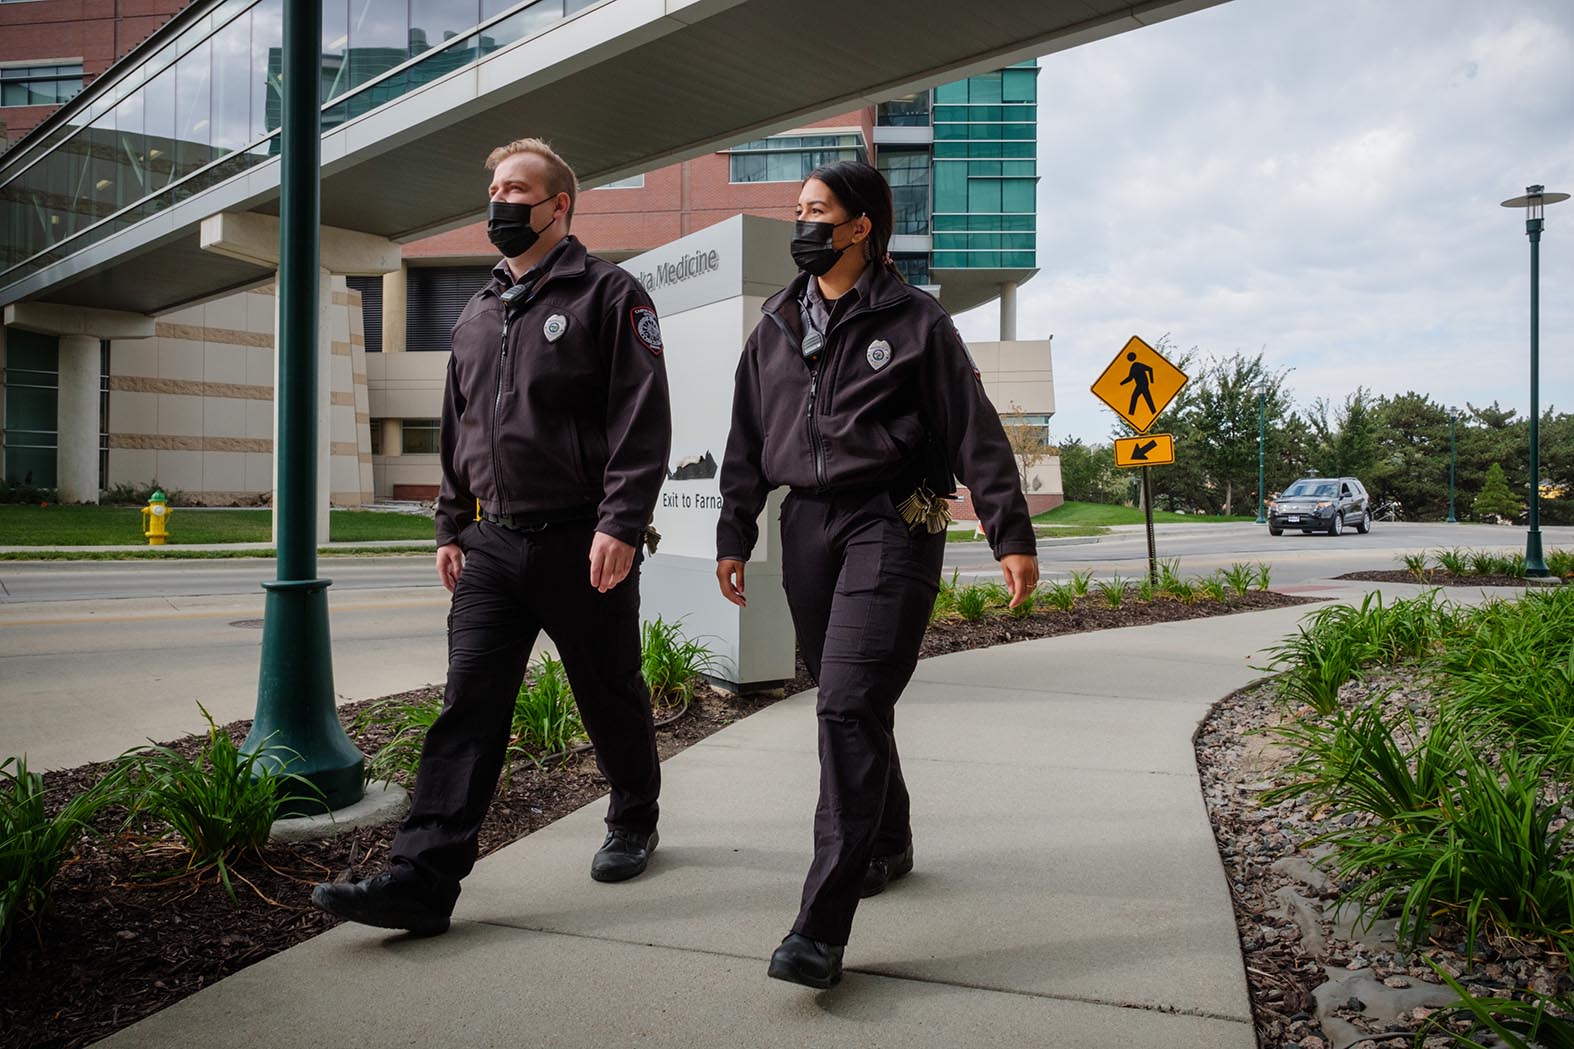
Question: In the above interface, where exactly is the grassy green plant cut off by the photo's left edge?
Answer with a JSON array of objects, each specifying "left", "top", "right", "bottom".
[{"left": 0, "top": 758, "right": 124, "bottom": 953}]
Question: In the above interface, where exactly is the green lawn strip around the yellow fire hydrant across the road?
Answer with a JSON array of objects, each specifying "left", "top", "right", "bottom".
[{"left": 0, "top": 506, "right": 431, "bottom": 547}]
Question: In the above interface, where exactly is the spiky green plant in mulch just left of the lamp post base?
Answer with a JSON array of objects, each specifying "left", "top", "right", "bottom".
[{"left": 121, "top": 702, "right": 323, "bottom": 898}]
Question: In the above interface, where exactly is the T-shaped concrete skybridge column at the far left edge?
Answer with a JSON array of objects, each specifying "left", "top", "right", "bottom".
[{"left": 5, "top": 302, "right": 153, "bottom": 502}]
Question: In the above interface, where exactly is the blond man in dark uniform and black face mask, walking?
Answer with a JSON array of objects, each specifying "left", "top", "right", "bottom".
[{"left": 312, "top": 139, "right": 672, "bottom": 934}]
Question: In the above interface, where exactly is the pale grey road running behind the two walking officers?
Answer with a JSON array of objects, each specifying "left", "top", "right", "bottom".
[{"left": 0, "top": 525, "right": 1574, "bottom": 769}]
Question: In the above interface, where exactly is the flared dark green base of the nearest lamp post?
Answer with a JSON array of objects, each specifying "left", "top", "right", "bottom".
[{"left": 241, "top": 580, "right": 367, "bottom": 816}]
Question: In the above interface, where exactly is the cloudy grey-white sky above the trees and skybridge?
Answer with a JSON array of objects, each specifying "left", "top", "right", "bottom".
[{"left": 959, "top": 0, "right": 1574, "bottom": 441}]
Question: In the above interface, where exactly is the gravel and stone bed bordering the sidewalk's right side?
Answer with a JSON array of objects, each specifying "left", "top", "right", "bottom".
[{"left": 1195, "top": 671, "right": 1574, "bottom": 1049}]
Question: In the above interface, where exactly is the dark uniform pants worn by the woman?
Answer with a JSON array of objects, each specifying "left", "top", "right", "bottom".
[{"left": 781, "top": 491, "right": 946, "bottom": 943}]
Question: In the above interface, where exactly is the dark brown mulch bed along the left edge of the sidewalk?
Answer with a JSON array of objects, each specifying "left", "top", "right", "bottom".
[{"left": 0, "top": 591, "right": 1313, "bottom": 1049}]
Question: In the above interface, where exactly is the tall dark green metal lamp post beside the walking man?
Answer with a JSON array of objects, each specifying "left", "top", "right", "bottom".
[{"left": 242, "top": 0, "right": 365, "bottom": 814}]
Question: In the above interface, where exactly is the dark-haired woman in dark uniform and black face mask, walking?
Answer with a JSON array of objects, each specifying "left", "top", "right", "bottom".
[{"left": 716, "top": 161, "right": 1039, "bottom": 988}]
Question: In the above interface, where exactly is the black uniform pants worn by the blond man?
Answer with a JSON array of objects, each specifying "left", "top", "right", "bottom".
[{"left": 389, "top": 521, "right": 661, "bottom": 904}]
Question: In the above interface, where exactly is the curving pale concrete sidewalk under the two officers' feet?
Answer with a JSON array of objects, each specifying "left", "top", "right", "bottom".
[{"left": 104, "top": 586, "right": 1362, "bottom": 1049}]
